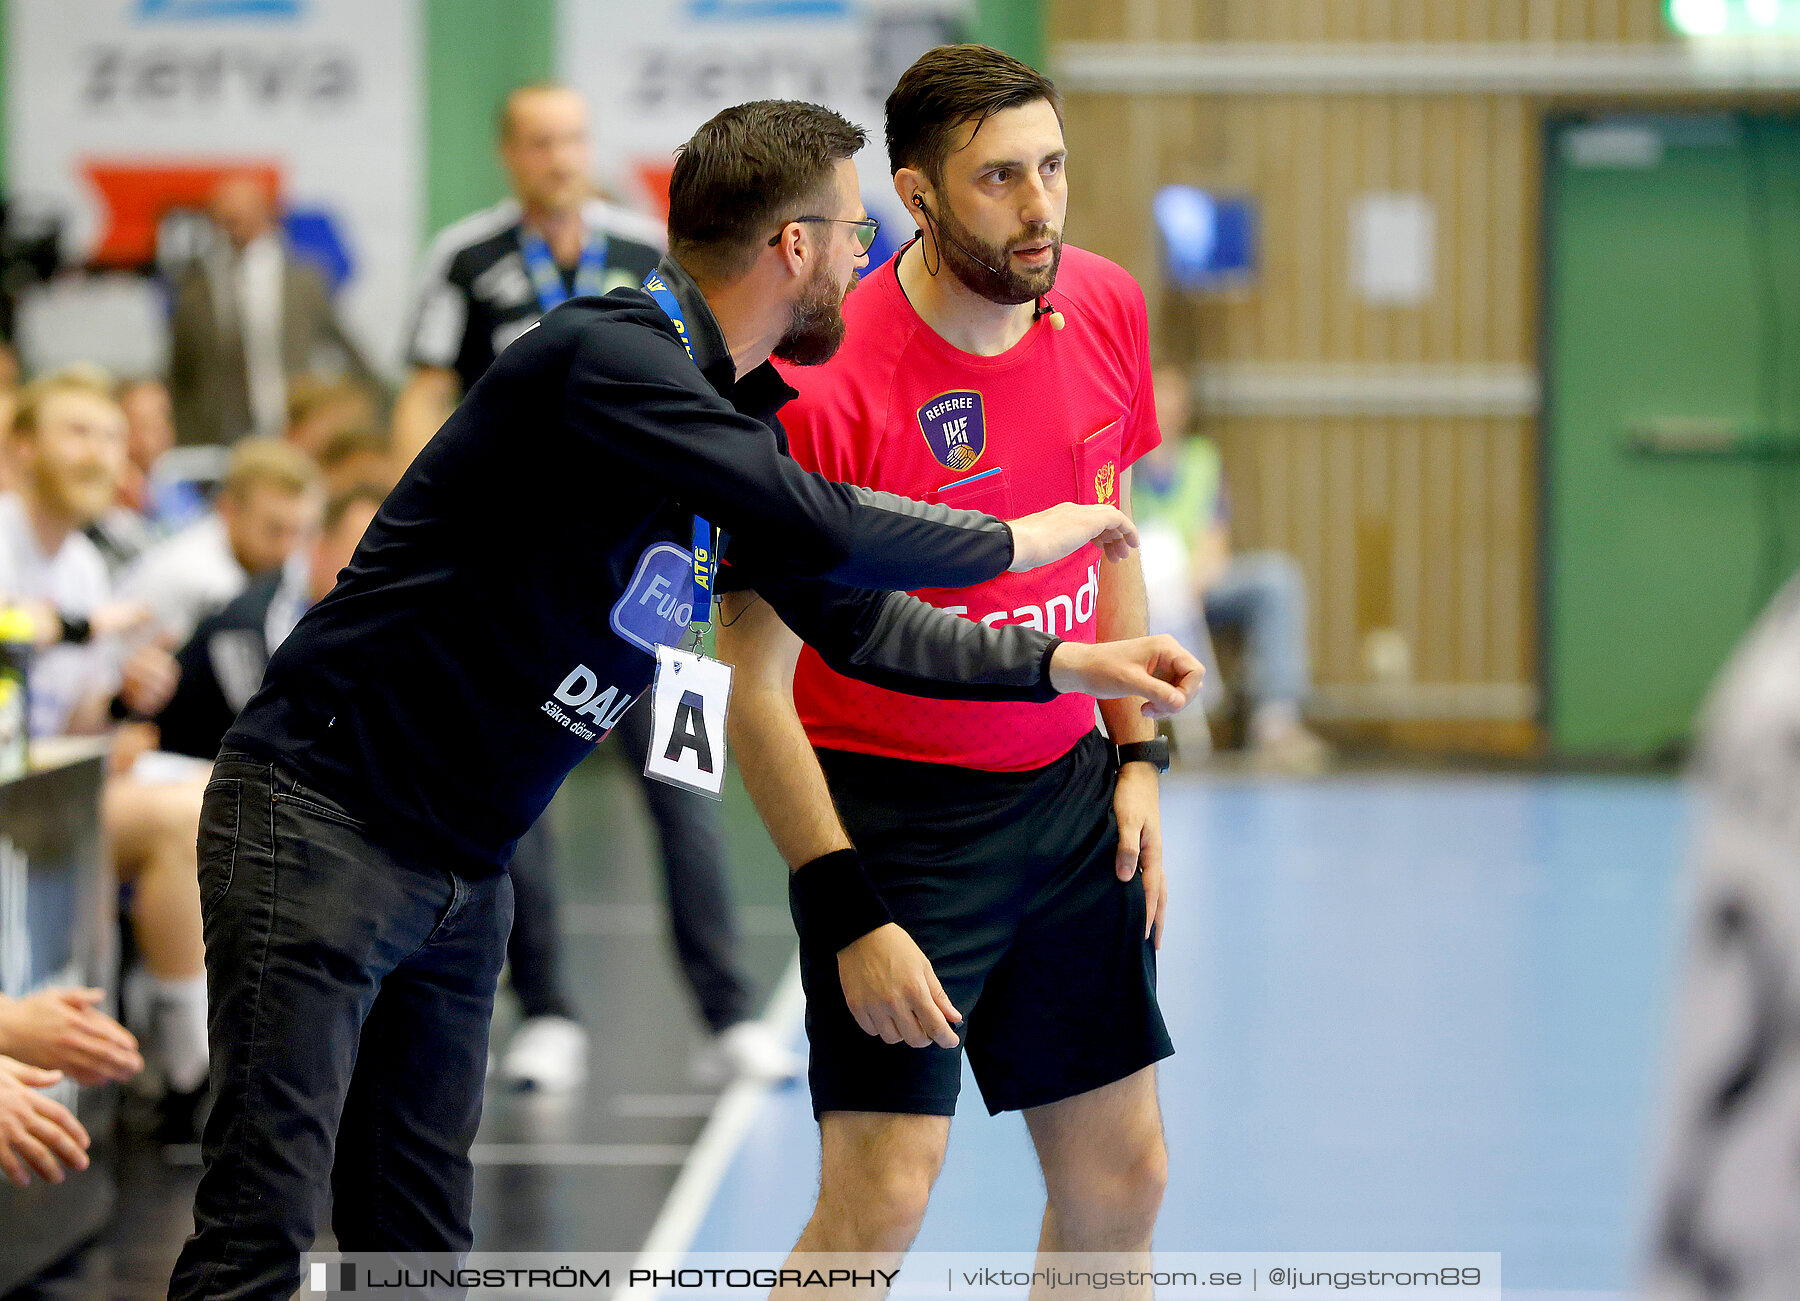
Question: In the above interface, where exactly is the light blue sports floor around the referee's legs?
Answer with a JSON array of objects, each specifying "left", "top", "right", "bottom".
[{"left": 691, "top": 776, "right": 1687, "bottom": 1294}]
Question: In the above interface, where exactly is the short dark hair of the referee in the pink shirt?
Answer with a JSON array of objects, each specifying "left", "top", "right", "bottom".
[{"left": 887, "top": 45, "right": 1062, "bottom": 185}]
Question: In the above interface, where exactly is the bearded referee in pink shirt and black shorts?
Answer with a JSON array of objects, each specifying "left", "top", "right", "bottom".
[{"left": 718, "top": 45, "right": 1174, "bottom": 1281}]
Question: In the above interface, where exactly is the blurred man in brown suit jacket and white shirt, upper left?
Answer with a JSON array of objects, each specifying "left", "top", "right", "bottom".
[{"left": 169, "top": 173, "right": 378, "bottom": 444}]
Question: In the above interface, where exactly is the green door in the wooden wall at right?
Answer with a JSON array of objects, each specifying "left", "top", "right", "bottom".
[{"left": 1543, "top": 115, "right": 1800, "bottom": 754}]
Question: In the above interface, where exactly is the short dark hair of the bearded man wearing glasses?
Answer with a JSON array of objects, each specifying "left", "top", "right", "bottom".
[{"left": 670, "top": 99, "right": 869, "bottom": 281}]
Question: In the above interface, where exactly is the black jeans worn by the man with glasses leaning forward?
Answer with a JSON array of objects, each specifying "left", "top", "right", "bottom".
[{"left": 169, "top": 754, "right": 513, "bottom": 1301}]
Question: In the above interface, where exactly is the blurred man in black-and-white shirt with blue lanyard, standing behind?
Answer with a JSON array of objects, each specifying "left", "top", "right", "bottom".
[{"left": 394, "top": 85, "right": 666, "bottom": 466}]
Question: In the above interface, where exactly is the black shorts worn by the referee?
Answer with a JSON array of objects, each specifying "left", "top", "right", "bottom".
[{"left": 801, "top": 732, "right": 1174, "bottom": 1116}]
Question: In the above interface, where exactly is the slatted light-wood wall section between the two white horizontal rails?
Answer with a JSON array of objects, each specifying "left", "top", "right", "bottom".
[{"left": 1067, "top": 92, "right": 1537, "bottom": 363}]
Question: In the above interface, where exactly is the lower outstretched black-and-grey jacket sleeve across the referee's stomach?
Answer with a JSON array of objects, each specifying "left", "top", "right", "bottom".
[{"left": 733, "top": 575, "right": 1062, "bottom": 702}]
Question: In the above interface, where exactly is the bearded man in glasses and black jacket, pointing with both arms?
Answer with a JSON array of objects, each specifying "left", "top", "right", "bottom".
[{"left": 171, "top": 101, "right": 1199, "bottom": 1299}]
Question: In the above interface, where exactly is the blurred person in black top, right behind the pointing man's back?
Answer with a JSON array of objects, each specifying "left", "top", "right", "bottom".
[{"left": 155, "top": 484, "right": 387, "bottom": 759}]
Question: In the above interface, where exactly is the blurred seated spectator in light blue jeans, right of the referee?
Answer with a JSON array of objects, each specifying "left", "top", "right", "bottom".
[{"left": 1132, "top": 365, "right": 1328, "bottom": 774}]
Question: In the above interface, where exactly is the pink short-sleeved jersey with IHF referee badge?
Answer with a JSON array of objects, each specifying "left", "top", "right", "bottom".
[{"left": 781, "top": 245, "right": 1161, "bottom": 772}]
